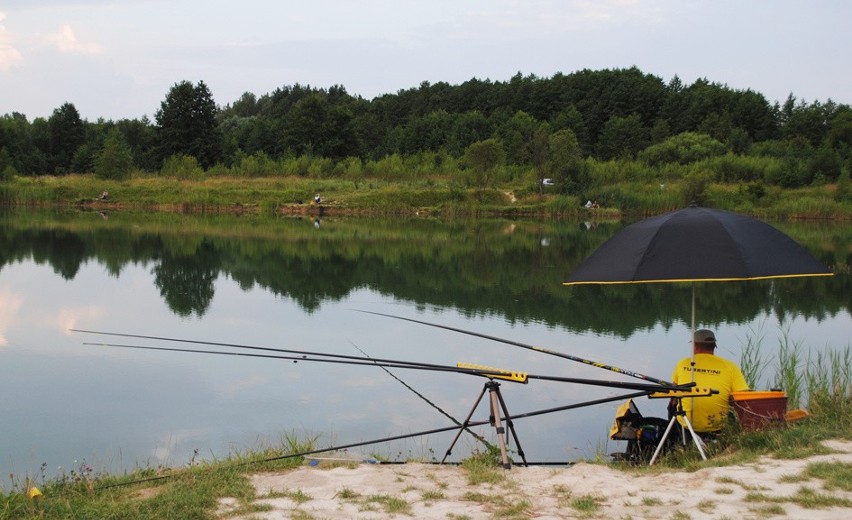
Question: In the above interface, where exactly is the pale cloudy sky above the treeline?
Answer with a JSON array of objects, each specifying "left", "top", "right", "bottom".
[{"left": 0, "top": 0, "right": 852, "bottom": 121}]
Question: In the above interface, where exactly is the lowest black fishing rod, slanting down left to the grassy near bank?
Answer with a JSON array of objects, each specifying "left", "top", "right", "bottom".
[{"left": 95, "top": 390, "right": 653, "bottom": 491}]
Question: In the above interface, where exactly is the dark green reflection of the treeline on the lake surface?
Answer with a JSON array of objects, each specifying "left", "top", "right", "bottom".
[{"left": 0, "top": 212, "right": 852, "bottom": 337}]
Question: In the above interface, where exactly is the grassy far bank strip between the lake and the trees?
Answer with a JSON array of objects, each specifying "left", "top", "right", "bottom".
[{"left": 0, "top": 175, "right": 852, "bottom": 220}]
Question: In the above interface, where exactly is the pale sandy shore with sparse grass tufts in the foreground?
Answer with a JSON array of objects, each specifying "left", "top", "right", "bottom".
[{"left": 220, "top": 441, "right": 852, "bottom": 520}]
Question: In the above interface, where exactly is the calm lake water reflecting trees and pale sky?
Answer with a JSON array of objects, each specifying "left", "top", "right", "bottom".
[{"left": 0, "top": 209, "right": 852, "bottom": 486}]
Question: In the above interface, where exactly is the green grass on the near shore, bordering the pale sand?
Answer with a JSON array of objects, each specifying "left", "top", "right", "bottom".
[{"left": 0, "top": 347, "right": 852, "bottom": 519}]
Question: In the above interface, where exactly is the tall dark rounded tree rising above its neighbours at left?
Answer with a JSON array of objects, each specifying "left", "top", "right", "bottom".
[{"left": 155, "top": 81, "right": 222, "bottom": 168}]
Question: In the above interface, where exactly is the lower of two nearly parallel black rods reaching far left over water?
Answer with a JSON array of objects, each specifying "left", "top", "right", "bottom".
[{"left": 83, "top": 342, "right": 684, "bottom": 393}]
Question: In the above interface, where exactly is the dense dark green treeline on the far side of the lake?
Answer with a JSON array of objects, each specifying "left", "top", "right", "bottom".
[{"left": 0, "top": 67, "right": 852, "bottom": 193}]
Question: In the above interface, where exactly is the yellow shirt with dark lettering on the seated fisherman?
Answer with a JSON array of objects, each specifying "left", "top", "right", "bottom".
[{"left": 672, "top": 354, "right": 748, "bottom": 432}]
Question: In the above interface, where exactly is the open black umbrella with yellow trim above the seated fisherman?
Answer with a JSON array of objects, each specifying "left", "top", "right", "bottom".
[{"left": 565, "top": 206, "right": 832, "bottom": 330}]
